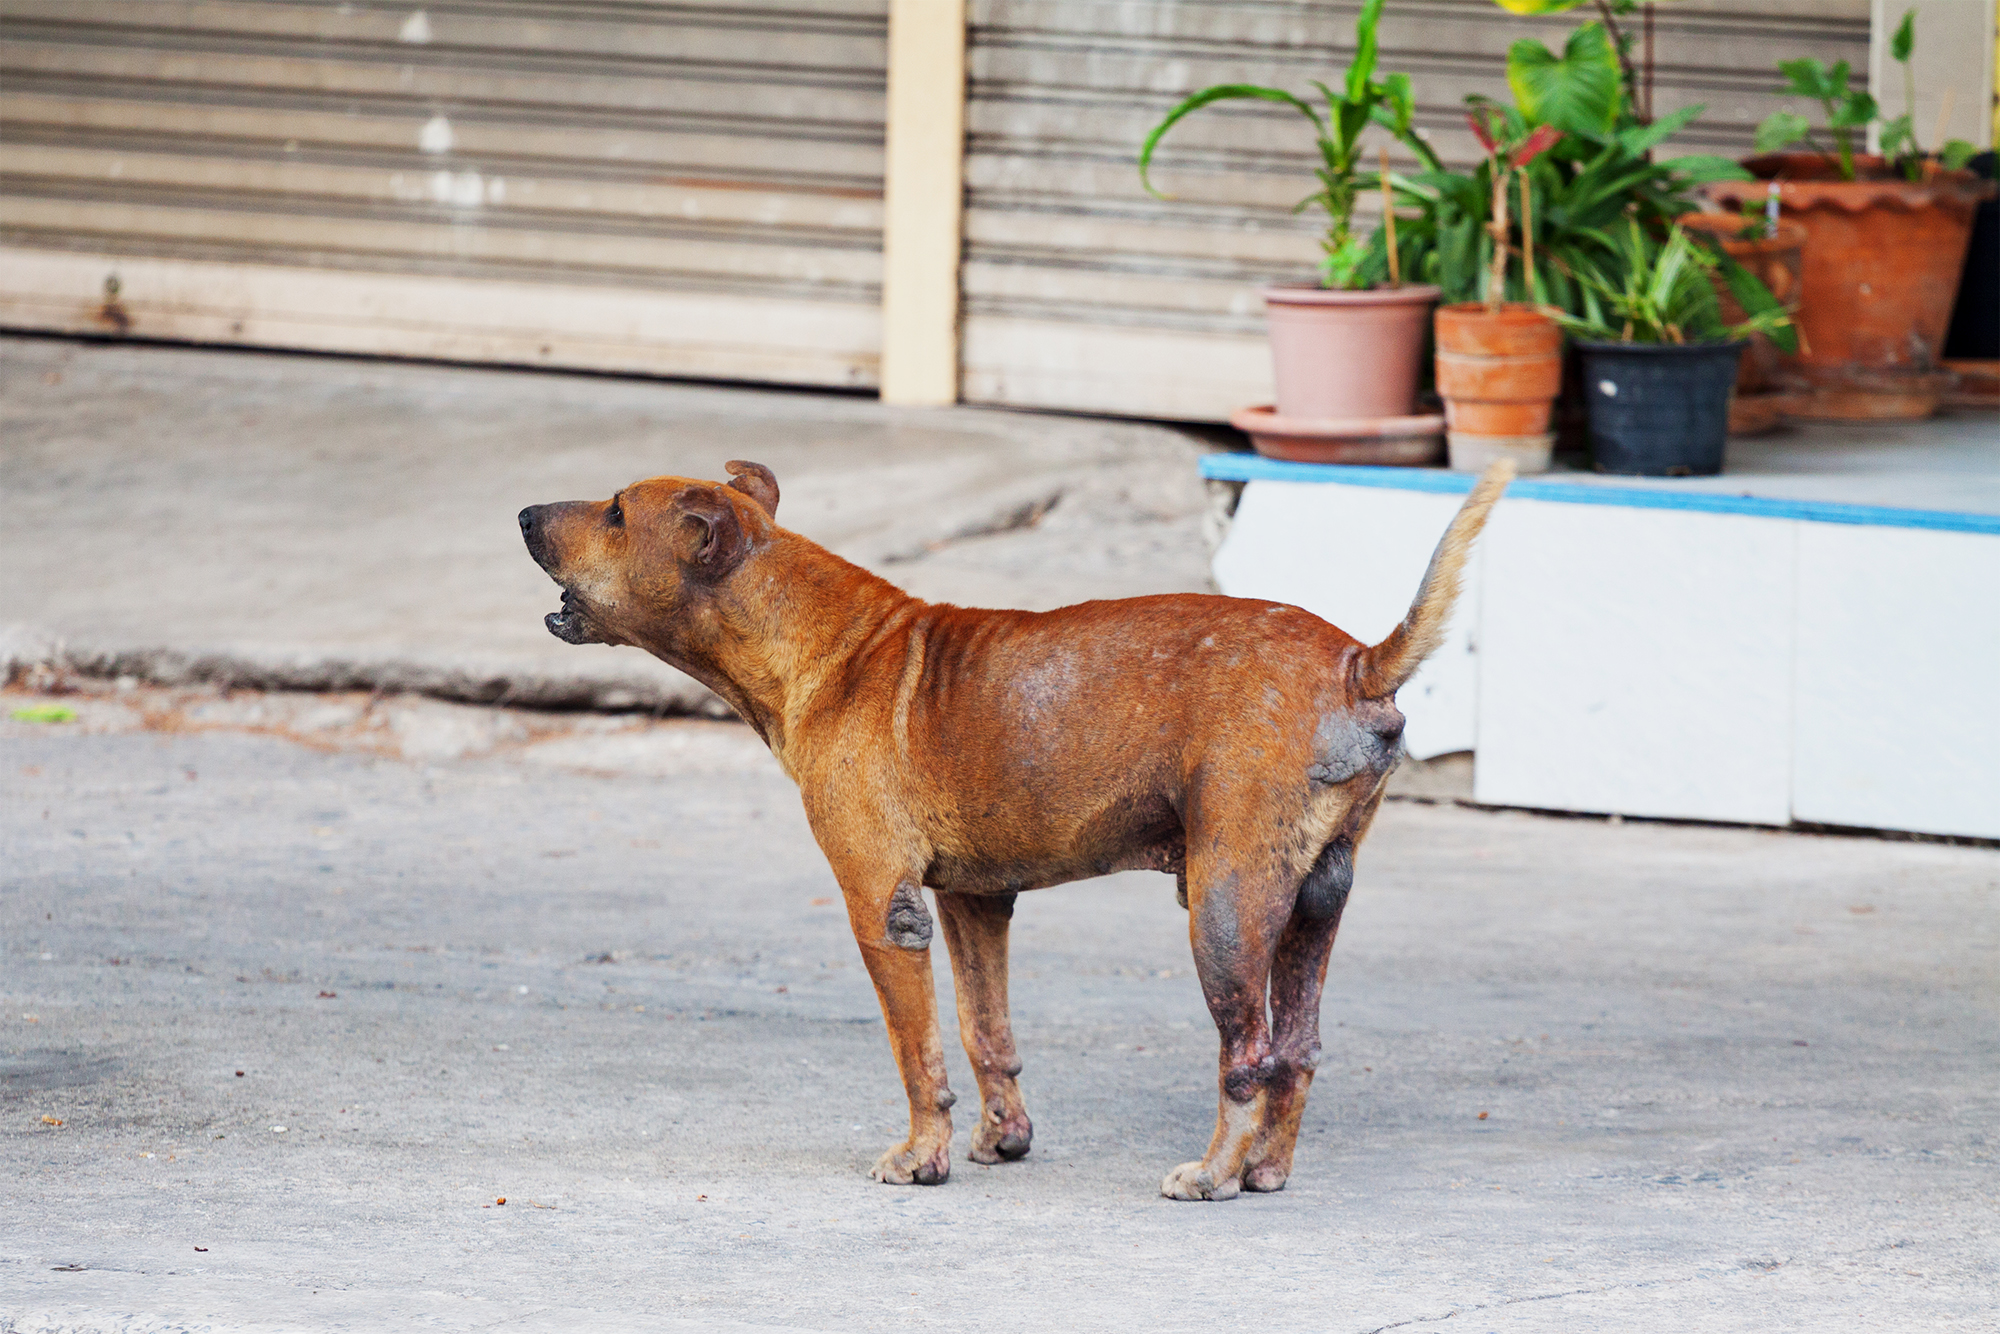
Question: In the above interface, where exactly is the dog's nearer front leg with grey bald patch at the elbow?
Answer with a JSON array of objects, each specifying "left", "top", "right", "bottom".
[{"left": 836, "top": 868, "right": 954, "bottom": 1186}]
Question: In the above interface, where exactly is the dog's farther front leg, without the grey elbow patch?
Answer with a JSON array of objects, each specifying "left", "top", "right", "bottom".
[{"left": 938, "top": 894, "right": 1034, "bottom": 1162}]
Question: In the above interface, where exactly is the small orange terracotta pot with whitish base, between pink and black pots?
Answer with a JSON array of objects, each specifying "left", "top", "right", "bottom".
[{"left": 1436, "top": 302, "right": 1562, "bottom": 472}]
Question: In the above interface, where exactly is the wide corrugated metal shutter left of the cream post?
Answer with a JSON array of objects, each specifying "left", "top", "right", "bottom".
[{"left": 0, "top": 0, "right": 886, "bottom": 386}]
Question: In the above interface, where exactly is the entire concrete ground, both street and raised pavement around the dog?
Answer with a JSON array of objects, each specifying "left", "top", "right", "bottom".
[{"left": 0, "top": 340, "right": 2000, "bottom": 1334}]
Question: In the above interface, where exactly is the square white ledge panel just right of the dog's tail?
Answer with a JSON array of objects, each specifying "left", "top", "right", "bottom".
[{"left": 1474, "top": 500, "right": 1798, "bottom": 824}]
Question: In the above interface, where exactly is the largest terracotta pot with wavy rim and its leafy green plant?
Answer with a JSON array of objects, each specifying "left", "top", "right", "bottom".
[{"left": 1710, "top": 10, "right": 1992, "bottom": 420}]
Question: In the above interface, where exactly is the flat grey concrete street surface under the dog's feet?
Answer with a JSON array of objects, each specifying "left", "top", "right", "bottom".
[{"left": 0, "top": 682, "right": 2000, "bottom": 1334}]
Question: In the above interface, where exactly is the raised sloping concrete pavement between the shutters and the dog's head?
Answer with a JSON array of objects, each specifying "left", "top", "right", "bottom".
[{"left": 0, "top": 336, "right": 1208, "bottom": 710}]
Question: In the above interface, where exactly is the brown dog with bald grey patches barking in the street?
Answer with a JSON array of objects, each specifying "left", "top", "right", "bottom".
[{"left": 520, "top": 462, "right": 1512, "bottom": 1200}]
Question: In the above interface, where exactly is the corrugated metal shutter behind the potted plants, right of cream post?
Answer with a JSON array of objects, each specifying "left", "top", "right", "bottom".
[{"left": 962, "top": 0, "right": 1870, "bottom": 420}]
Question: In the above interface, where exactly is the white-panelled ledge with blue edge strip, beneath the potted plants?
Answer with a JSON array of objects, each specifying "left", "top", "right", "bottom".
[{"left": 1202, "top": 420, "right": 2000, "bottom": 838}]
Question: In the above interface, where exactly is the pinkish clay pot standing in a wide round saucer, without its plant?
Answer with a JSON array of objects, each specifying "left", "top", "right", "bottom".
[{"left": 1264, "top": 284, "right": 1438, "bottom": 420}]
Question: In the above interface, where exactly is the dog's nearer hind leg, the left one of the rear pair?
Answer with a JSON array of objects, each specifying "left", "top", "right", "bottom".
[{"left": 1160, "top": 852, "right": 1292, "bottom": 1200}]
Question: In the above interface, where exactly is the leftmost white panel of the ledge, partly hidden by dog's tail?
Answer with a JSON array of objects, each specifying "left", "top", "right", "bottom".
[{"left": 1214, "top": 482, "right": 1488, "bottom": 760}]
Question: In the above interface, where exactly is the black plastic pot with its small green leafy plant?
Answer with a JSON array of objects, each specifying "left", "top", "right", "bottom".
[{"left": 1544, "top": 216, "right": 1790, "bottom": 476}]
